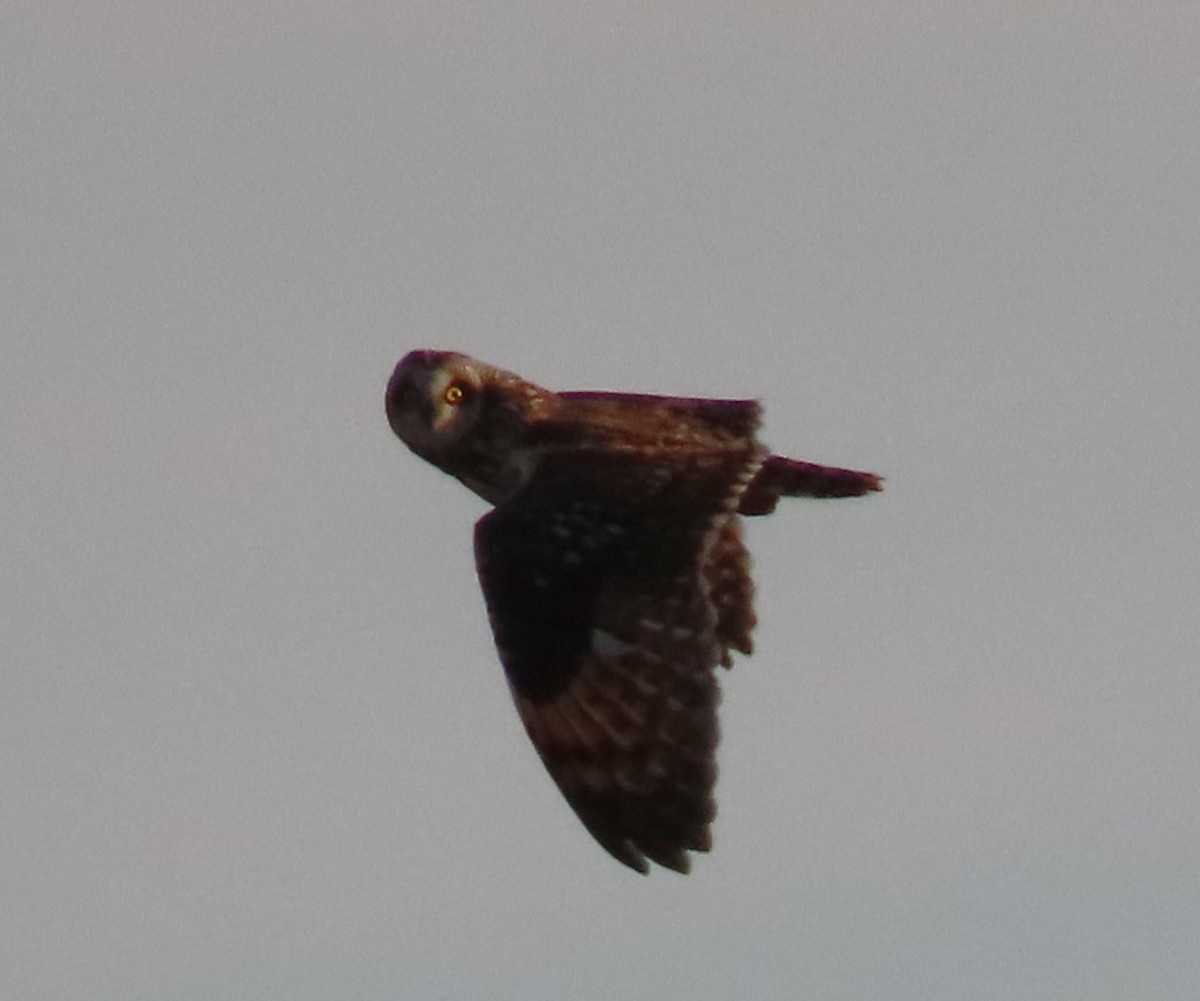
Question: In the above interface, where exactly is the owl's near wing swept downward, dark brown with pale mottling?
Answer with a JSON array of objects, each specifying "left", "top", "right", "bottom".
[{"left": 475, "top": 442, "right": 761, "bottom": 873}]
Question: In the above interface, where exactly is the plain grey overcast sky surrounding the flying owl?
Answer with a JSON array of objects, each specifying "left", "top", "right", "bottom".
[{"left": 0, "top": 0, "right": 1200, "bottom": 1001}]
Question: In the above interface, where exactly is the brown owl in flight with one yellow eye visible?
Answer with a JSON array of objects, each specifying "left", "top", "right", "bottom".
[{"left": 386, "top": 350, "right": 881, "bottom": 873}]
